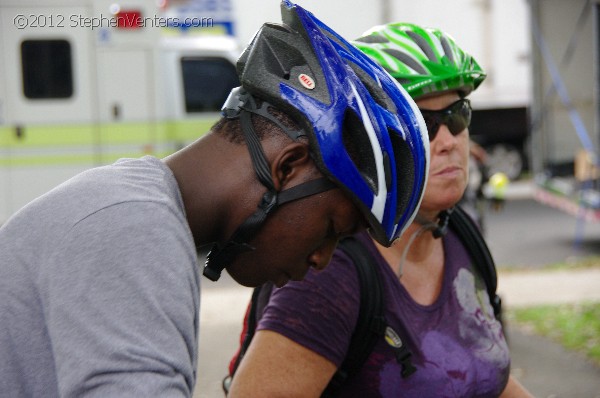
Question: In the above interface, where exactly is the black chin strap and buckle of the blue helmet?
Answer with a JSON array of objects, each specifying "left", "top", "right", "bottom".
[{"left": 204, "top": 90, "right": 336, "bottom": 281}]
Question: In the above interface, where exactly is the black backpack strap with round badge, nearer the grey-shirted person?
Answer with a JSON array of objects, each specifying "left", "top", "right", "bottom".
[{"left": 321, "top": 237, "right": 415, "bottom": 397}]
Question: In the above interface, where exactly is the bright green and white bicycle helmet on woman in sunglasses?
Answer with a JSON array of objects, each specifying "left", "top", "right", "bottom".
[{"left": 352, "top": 22, "right": 486, "bottom": 99}]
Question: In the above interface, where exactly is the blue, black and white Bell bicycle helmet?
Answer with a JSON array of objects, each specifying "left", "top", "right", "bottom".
[{"left": 205, "top": 0, "right": 429, "bottom": 280}]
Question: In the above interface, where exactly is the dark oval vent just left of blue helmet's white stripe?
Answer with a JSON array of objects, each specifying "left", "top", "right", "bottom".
[{"left": 342, "top": 110, "right": 378, "bottom": 192}]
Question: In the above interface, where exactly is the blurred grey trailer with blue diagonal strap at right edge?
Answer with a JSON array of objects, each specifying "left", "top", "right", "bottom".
[{"left": 530, "top": 0, "right": 600, "bottom": 221}]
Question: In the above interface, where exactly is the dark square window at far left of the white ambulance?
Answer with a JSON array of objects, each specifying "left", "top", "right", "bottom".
[{"left": 21, "top": 40, "right": 73, "bottom": 99}]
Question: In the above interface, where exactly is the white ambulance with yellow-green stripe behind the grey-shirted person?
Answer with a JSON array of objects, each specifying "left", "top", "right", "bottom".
[{"left": 0, "top": 0, "right": 239, "bottom": 224}]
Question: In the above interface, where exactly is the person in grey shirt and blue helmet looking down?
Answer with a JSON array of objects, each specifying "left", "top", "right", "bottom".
[{"left": 0, "top": 2, "right": 428, "bottom": 398}]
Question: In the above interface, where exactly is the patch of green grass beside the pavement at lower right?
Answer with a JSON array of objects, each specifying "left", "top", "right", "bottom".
[{"left": 506, "top": 303, "right": 600, "bottom": 365}]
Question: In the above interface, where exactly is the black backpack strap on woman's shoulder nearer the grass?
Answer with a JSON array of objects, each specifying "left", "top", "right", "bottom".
[{"left": 450, "top": 206, "right": 502, "bottom": 323}]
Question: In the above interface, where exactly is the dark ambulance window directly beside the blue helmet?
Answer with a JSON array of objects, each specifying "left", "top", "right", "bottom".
[{"left": 181, "top": 57, "right": 240, "bottom": 113}]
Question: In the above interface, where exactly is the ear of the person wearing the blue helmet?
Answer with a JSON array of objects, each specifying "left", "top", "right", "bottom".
[{"left": 271, "top": 142, "right": 315, "bottom": 191}]
